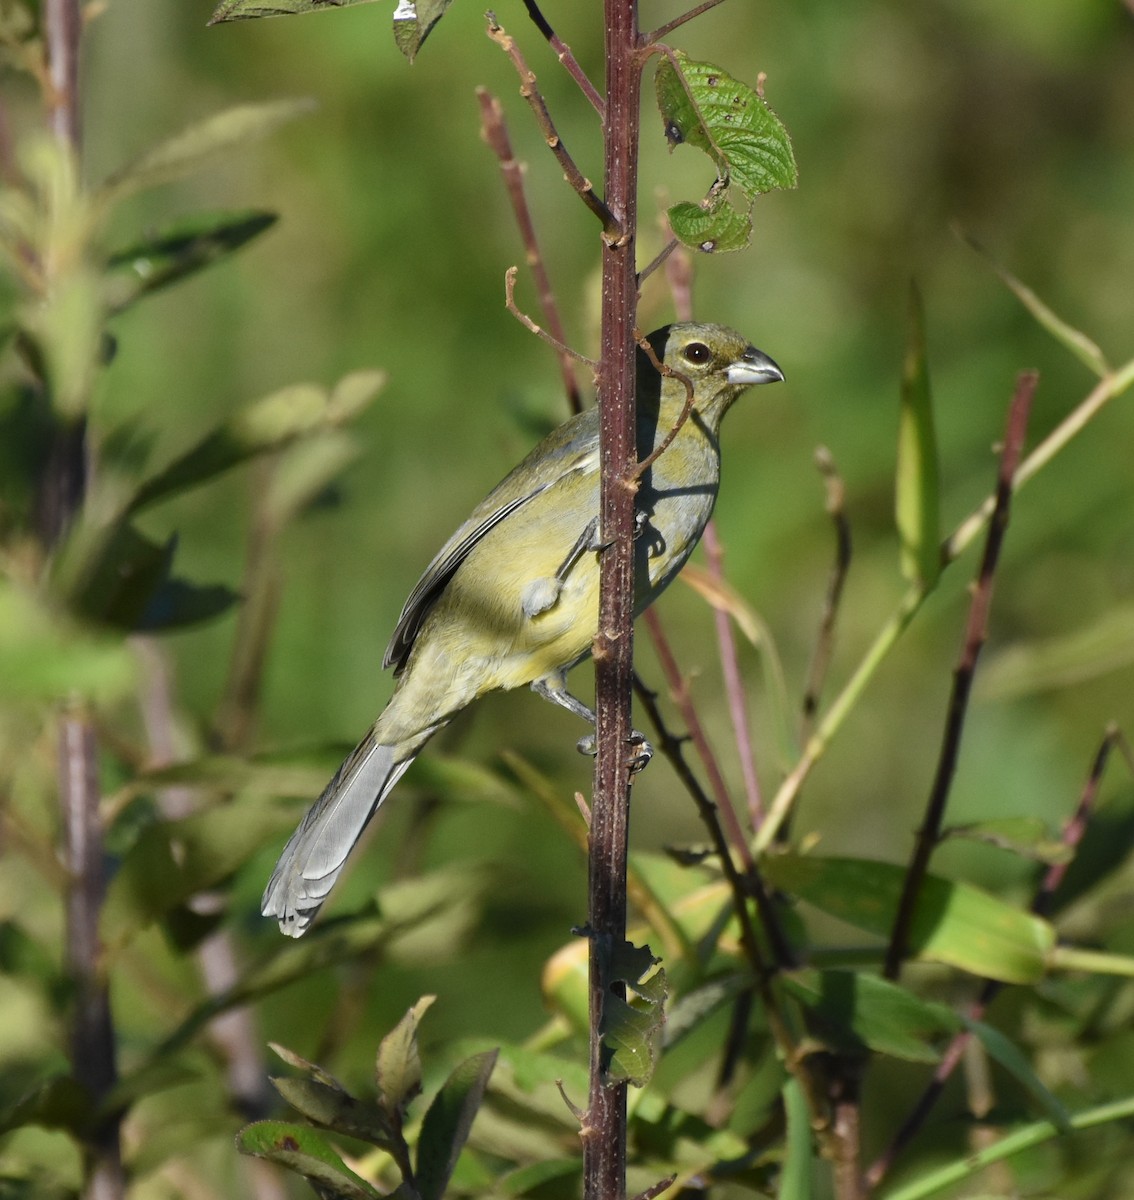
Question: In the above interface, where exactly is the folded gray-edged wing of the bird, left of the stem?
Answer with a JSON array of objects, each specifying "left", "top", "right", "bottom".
[{"left": 382, "top": 409, "right": 599, "bottom": 673}]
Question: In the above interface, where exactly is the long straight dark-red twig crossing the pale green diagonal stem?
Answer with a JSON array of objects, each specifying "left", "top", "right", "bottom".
[{"left": 883, "top": 371, "right": 1039, "bottom": 979}]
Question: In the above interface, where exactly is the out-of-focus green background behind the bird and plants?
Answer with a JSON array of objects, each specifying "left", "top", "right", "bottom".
[{"left": 0, "top": 0, "right": 1134, "bottom": 1195}]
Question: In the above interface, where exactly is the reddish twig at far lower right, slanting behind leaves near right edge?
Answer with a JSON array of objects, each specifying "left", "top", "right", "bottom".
[{"left": 865, "top": 726, "right": 1124, "bottom": 1188}]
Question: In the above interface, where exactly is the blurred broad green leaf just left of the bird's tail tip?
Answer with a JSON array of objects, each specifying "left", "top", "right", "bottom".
[{"left": 101, "top": 804, "right": 288, "bottom": 949}]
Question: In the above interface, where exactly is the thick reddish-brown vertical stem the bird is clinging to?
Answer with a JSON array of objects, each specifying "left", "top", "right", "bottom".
[{"left": 583, "top": 9, "right": 642, "bottom": 1200}]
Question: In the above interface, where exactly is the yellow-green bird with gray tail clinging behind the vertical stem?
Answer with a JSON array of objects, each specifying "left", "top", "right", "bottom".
[{"left": 263, "top": 322, "right": 784, "bottom": 937}]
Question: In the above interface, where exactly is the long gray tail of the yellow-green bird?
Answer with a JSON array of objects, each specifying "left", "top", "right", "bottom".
[{"left": 260, "top": 732, "right": 416, "bottom": 937}]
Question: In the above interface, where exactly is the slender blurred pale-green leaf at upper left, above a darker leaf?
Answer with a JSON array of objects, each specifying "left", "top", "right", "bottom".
[{"left": 98, "top": 100, "right": 316, "bottom": 205}]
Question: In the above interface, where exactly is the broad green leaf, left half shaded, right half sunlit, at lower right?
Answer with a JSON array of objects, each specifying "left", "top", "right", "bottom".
[{"left": 763, "top": 854, "right": 1055, "bottom": 983}]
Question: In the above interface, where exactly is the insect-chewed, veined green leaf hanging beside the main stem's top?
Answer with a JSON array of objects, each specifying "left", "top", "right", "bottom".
[{"left": 655, "top": 50, "right": 797, "bottom": 251}]
